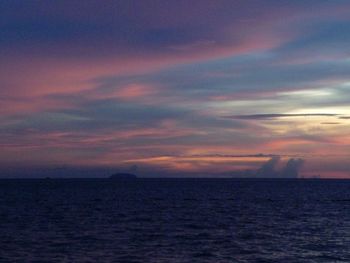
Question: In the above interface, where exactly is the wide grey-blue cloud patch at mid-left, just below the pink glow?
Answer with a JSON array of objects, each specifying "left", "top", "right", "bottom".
[{"left": 0, "top": 100, "right": 191, "bottom": 132}]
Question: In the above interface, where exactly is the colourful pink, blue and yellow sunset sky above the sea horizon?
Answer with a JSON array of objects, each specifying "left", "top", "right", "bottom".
[{"left": 0, "top": 0, "right": 350, "bottom": 178}]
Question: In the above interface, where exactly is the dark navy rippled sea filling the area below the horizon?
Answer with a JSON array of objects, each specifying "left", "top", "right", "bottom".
[{"left": 0, "top": 179, "right": 350, "bottom": 263}]
